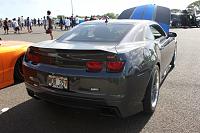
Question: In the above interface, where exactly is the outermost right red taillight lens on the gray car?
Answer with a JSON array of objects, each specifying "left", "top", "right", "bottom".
[{"left": 106, "top": 61, "right": 125, "bottom": 72}]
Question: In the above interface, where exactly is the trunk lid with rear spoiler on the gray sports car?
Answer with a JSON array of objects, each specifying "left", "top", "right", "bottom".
[{"left": 29, "top": 41, "right": 119, "bottom": 69}]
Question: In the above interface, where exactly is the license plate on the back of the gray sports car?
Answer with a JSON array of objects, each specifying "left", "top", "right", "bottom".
[{"left": 47, "top": 75, "right": 68, "bottom": 89}]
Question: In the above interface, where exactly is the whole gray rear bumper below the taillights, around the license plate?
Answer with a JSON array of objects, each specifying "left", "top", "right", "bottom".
[{"left": 23, "top": 62, "right": 152, "bottom": 117}]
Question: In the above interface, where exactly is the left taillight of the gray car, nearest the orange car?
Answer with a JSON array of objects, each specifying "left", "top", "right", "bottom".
[{"left": 26, "top": 49, "right": 40, "bottom": 64}]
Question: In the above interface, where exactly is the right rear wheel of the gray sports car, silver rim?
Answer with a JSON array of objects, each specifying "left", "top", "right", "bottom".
[{"left": 143, "top": 65, "right": 160, "bottom": 115}]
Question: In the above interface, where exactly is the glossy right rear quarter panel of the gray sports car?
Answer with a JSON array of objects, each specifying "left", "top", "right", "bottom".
[{"left": 117, "top": 41, "right": 158, "bottom": 101}]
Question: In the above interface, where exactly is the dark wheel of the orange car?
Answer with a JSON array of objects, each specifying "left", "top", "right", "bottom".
[{"left": 14, "top": 56, "right": 24, "bottom": 82}]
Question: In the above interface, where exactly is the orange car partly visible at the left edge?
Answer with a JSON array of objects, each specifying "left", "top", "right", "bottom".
[{"left": 0, "top": 40, "right": 31, "bottom": 89}]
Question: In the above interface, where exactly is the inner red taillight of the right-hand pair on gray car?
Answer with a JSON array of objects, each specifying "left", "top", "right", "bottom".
[{"left": 86, "top": 61, "right": 103, "bottom": 72}]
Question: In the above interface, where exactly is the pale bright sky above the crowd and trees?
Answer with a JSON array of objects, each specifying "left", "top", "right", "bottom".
[{"left": 0, "top": 0, "right": 195, "bottom": 18}]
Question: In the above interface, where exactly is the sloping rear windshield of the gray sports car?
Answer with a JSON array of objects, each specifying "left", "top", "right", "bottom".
[{"left": 57, "top": 23, "right": 133, "bottom": 42}]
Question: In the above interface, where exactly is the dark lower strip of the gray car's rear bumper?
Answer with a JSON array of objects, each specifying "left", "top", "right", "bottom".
[{"left": 25, "top": 83, "right": 143, "bottom": 118}]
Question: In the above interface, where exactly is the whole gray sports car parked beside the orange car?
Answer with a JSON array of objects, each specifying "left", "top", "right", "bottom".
[{"left": 23, "top": 20, "right": 177, "bottom": 117}]
